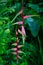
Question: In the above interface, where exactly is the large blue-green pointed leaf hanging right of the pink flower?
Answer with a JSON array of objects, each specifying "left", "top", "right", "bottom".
[{"left": 25, "top": 18, "right": 40, "bottom": 37}]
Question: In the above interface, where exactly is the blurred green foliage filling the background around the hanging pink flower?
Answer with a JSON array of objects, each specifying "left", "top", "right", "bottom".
[{"left": 0, "top": 0, "right": 43, "bottom": 65}]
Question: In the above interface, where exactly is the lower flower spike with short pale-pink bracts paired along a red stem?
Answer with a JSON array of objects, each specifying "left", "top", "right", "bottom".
[{"left": 11, "top": 31, "right": 23, "bottom": 61}]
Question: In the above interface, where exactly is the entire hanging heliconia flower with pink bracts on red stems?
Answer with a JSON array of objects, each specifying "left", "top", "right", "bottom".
[{"left": 11, "top": 9, "right": 37, "bottom": 63}]
